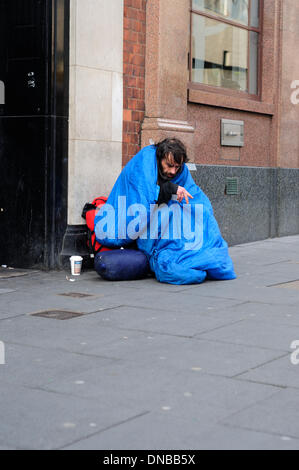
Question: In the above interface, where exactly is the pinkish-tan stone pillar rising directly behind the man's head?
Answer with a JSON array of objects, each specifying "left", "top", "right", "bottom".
[{"left": 142, "top": 0, "right": 194, "bottom": 159}]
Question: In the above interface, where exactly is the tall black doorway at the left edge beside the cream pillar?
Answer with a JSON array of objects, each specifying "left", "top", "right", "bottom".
[{"left": 0, "top": 0, "right": 69, "bottom": 268}]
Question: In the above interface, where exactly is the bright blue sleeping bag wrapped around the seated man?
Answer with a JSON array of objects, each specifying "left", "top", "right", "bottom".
[{"left": 95, "top": 146, "right": 236, "bottom": 284}]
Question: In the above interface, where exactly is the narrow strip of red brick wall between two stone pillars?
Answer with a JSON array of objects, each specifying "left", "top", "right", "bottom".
[{"left": 122, "top": 0, "right": 146, "bottom": 165}]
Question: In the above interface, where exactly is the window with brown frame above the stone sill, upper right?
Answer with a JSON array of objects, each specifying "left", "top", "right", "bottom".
[{"left": 191, "top": 0, "right": 260, "bottom": 95}]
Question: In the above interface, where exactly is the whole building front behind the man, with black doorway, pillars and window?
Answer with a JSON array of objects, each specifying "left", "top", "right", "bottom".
[{"left": 0, "top": 0, "right": 299, "bottom": 268}]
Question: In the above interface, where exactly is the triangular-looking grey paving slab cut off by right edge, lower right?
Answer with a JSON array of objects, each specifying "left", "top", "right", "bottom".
[{"left": 238, "top": 349, "right": 299, "bottom": 389}]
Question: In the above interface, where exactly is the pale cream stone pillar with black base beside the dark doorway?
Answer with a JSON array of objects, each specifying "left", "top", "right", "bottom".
[{"left": 62, "top": 0, "right": 123, "bottom": 255}]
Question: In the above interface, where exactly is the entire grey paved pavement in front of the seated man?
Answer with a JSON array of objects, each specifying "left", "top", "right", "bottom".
[{"left": 0, "top": 236, "right": 299, "bottom": 450}]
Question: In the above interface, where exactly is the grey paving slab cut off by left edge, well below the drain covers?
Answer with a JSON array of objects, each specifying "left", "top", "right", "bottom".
[{"left": 0, "top": 343, "right": 117, "bottom": 387}]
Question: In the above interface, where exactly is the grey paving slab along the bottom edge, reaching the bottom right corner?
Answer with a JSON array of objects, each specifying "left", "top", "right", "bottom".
[{"left": 64, "top": 411, "right": 299, "bottom": 450}]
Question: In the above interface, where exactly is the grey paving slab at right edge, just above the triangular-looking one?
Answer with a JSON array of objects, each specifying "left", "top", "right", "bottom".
[{"left": 197, "top": 318, "right": 299, "bottom": 351}]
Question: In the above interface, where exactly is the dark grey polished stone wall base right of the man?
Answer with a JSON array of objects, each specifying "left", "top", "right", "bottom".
[{"left": 191, "top": 165, "right": 299, "bottom": 245}]
